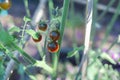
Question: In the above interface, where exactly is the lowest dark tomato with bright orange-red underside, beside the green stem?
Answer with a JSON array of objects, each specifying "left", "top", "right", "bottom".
[{"left": 47, "top": 41, "right": 59, "bottom": 53}]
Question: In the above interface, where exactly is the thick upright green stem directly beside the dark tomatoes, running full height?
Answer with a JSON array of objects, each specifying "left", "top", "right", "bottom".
[{"left": 52, "top": 0, "right": 70, "bottom": 80}]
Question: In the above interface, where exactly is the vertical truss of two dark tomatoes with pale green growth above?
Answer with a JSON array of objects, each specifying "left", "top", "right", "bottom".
[{"left": 47, "top": 8, "right": 61, "bottom": 53}]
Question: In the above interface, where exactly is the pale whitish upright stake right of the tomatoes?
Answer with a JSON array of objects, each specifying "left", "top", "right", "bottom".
[{"left": 75, "top": 0, "right": 93, "bottom": 80}]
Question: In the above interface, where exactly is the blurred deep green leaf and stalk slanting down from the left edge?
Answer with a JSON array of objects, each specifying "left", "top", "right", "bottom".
[{"left": 0, "top": 24, "right": 36, "bottom": 63}]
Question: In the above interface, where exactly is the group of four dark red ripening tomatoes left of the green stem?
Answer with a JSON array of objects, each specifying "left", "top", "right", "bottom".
[{"left": 32, "top": 22, "right": 60, "bottom": 53}]
